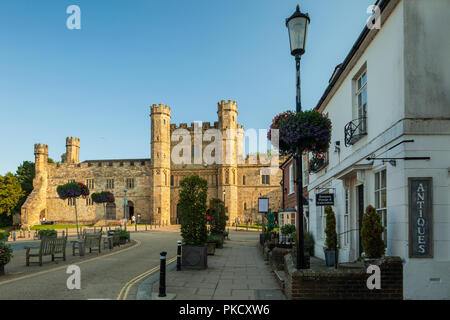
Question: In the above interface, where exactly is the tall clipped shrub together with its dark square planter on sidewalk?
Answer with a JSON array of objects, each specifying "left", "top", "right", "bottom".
[{"left": 179, "top": 175, "right": 208, "bottom": 269}]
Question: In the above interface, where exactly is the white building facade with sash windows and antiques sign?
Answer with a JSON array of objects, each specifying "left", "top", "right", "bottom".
[{"left": 308, "top": 0, "right": 450, "bottom": 299}]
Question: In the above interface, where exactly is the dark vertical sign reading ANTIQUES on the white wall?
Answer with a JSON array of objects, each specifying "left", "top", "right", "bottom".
[{"left": 408, "top": 178, "right": 433, "bottom": 258}]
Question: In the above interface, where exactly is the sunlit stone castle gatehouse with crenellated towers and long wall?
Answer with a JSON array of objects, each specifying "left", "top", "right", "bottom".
[{"left": 21, "top": 100, "right": 282, "bottom": 228}]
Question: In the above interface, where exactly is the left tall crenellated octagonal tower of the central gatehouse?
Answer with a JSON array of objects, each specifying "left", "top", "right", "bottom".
[{"left": 150, "top": 104, "right": 170, "bottom": 225}]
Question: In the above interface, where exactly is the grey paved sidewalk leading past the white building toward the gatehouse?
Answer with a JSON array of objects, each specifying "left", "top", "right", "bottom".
[{"left": 152, "top": 232, "right": 285, "bottom": 300}]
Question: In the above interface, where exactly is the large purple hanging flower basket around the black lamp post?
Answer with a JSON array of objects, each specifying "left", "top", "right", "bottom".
[{"left": 267, "top": 110, "right": 331, "bottom": 154}]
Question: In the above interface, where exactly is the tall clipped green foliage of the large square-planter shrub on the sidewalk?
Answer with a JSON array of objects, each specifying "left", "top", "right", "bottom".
[{"left": 179, "top": 175, "right": 208, "bottom": 246}]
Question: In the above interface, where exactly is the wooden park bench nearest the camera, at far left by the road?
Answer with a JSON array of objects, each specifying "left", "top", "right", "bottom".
[{"left": 24, "top": 237, "right": 67, "bottom": 266}]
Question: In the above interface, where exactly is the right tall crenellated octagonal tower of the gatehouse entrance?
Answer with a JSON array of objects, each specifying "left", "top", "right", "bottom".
[{"left": 217, "top": 100, "right": 240, "bottom": 224}]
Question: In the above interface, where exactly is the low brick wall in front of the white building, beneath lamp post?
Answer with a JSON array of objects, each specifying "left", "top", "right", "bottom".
[{"left": 284, "top": 254, "right": 403, "bottom": 300}]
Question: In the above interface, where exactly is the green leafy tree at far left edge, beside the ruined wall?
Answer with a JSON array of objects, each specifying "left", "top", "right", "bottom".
[{"left": 0, "top": 172, "right": 24, "bottom": 216}]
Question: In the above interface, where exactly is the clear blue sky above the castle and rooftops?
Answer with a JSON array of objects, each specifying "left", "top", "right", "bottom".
[{"left": 0, "top": 0, "right": 375, "bottom": 174}]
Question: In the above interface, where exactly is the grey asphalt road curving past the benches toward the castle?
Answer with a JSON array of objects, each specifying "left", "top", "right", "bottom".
[{"left": 0, "top": 231, "right": 180, "bottom": 300}]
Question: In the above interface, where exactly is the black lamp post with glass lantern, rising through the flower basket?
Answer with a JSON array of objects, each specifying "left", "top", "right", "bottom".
[{"left": 286, "top": 5, "right": 310, "bottom": 269}]
